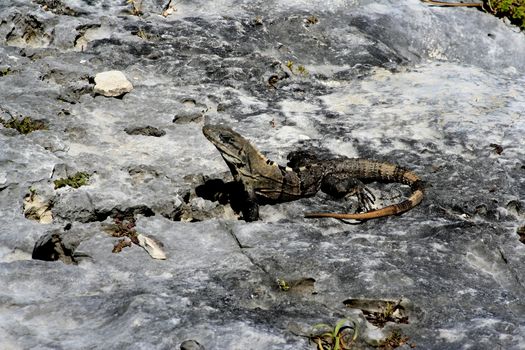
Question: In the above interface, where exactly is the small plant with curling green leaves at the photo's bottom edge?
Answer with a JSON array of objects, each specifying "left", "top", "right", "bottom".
[{"left": 308, "top": 318, "right": 358, "bottom": 350}]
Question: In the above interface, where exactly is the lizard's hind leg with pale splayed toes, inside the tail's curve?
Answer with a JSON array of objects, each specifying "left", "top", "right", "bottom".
[{"left": 321, "top": 173, "right": 376, "bottom": 211}]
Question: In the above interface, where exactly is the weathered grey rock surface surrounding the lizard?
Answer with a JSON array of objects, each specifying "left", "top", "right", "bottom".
[{"left": 0, "top": 0, "right": 525, "bottom": 350}]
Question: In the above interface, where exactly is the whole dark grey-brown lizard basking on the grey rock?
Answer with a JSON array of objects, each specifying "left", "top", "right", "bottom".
[{"left": 202, "top": 125, "right": 424, "bottom": 221}]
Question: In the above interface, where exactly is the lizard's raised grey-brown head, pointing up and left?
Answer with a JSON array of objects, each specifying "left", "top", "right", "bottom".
[{"left": 202, "top": 125, "right": 259, "bottom": 171}]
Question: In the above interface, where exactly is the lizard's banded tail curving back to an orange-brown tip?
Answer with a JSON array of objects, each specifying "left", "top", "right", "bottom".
[{"left": 304, "top": 164, "right": 424, "bottom": 220}]
